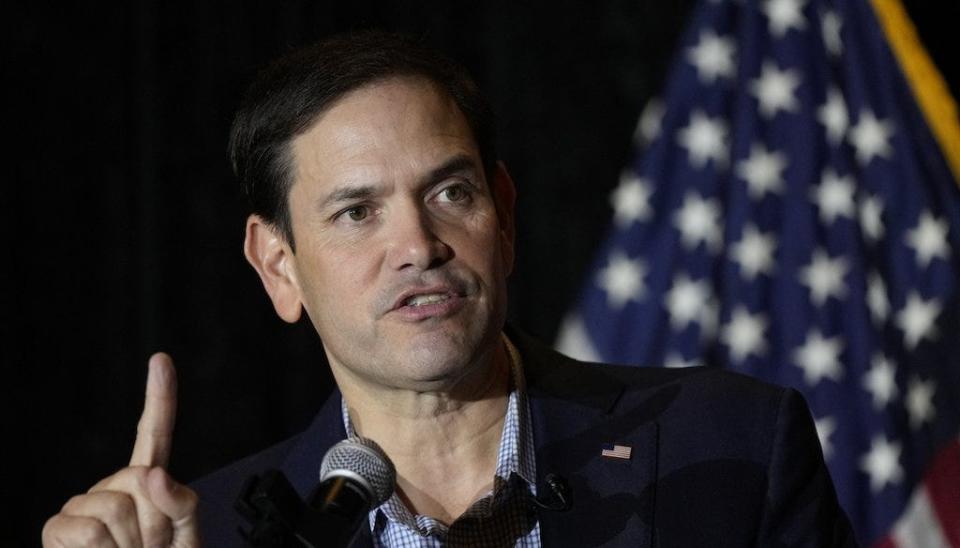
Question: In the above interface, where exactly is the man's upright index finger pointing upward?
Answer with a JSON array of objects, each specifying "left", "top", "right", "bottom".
[{"left": 130, "top": 352, "right": 177, "bottom": 467}]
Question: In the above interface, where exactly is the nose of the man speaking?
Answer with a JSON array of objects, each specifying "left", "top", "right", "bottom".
[{"left": 388, "top": 208, "right": 453, "bottom": 270}]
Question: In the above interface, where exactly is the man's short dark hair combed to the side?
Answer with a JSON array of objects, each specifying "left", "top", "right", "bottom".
[{"left": 229, "top": 31, "right": 496, "bottom": 247}]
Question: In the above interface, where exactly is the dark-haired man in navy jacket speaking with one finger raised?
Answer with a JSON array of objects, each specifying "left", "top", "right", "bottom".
[{"left": 43, "top": 33, "right": 853, "bottom": 546}]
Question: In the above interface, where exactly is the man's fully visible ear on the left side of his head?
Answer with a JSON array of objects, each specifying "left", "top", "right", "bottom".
[{"left": 243, "top": 215, "right": 303, "bottom": 323}]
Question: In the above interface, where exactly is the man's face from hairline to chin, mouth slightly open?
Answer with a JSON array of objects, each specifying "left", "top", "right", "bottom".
[{"left": 289, "top": 78, "right": 513, "bottom": 390}]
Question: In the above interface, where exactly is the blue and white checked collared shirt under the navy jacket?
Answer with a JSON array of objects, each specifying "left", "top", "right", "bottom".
[{"left": 341, "top": 335, "right": 540, "bottom": 548}]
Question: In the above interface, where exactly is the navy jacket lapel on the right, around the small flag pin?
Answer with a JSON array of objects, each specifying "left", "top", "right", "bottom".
[{"left": 510, "top": 332, "right": 658, "bottom": 547}]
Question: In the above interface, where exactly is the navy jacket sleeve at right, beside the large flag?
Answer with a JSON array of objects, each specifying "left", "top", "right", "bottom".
[{"left": 757, "top": 389, "right": 857, "bottom": 547}]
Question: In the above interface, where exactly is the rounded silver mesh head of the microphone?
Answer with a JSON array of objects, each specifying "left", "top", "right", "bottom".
[{"left": 320, "top": 437, "right": 397, "bottom": 508}]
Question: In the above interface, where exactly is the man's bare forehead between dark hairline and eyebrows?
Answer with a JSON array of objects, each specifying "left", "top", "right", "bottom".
[{"left": 291, "top": 78, "right": 479, "bottom": 193}]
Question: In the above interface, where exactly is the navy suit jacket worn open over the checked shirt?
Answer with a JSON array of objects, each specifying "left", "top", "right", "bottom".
[{"left": 193, "top": 332, "right": 856, "bottom": 547}]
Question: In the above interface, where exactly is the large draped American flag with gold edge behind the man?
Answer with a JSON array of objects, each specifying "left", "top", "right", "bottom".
[{"left": 558, "top": 0, "right": 960, "bottom": 547}]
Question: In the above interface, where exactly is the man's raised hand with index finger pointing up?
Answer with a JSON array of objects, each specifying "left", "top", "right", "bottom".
[{"left": 43, "top": 353, "right": 200, "bottom": 548}]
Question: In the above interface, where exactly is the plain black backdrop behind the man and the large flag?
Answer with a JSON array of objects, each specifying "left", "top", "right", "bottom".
[{"left": 7, "top": 0, "right": 960, "bottom": 546}]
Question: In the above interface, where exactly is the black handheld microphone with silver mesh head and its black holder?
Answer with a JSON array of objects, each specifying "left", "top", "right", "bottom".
[{"left": 235, "top": 437, "right": 397, "bottom": 548}]
